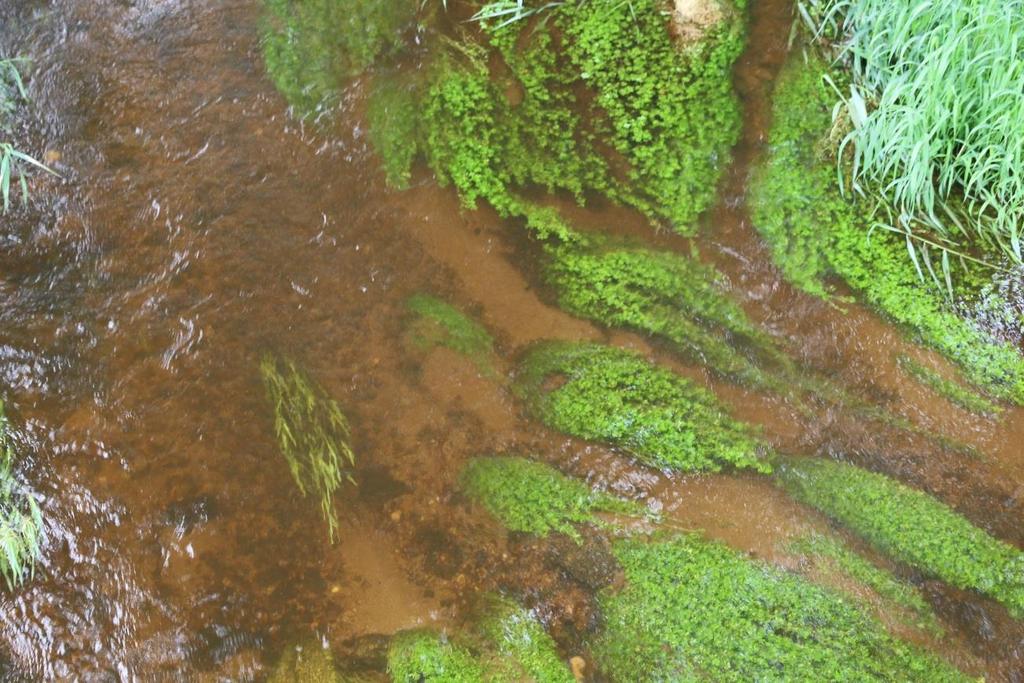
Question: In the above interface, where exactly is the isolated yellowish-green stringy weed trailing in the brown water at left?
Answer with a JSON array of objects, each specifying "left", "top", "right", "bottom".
[{"left": 260, "top": 353, "right": 355, "bottom": 542}]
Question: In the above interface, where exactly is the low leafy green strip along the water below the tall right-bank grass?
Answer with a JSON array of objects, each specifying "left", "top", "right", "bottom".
[{"left": 751, "top": 53, "right": 1024, "bottom": 403}]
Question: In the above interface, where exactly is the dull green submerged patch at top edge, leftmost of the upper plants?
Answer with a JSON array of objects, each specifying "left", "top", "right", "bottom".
[{"left": 262, "top": 0, "right": 417, "bottom": 116}]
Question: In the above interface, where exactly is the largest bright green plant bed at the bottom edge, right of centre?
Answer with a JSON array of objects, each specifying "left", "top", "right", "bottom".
[{"left": 593, "top": 536, "right": 970, "bottom": 683}]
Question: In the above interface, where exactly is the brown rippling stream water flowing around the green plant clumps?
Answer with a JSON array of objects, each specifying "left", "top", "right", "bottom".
[{"left": 0, "top": 0, "right": 1024, "bottom": 681}]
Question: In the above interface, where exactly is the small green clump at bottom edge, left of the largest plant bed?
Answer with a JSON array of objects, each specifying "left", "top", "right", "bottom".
[{"left": 388, "top": 596, "right": 573, "bottom": 683}]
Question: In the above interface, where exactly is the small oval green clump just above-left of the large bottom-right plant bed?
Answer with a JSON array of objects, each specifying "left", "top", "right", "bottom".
[{"left": 460, "top": 457, "right": 643, "bottom": 541}]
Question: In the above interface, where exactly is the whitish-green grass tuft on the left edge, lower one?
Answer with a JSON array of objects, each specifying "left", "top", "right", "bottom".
[{"left": 0, "top": 402, "right": 43, "bottom": 590}]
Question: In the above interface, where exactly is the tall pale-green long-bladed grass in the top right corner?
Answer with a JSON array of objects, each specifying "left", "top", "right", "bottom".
[{"left": 811, "top": 0, "right": 1024, "bottom": 264}]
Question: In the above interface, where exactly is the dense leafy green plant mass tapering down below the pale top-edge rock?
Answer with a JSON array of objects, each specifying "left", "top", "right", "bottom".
[{"left": 556, "top": 0, "right": 745, "bottom": 233}]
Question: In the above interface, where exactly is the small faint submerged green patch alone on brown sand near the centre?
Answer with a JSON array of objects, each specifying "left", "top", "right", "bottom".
[{"left": 406, "top": 294, "right": 497, "bottom": 377}]
